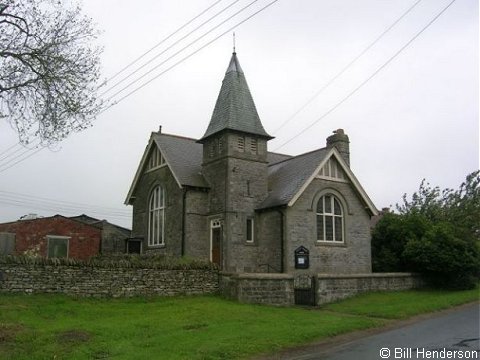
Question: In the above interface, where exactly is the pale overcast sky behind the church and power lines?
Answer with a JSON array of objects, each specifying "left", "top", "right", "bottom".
[{"left": 0, "top": 0, "right": 479, "bottom": 227}]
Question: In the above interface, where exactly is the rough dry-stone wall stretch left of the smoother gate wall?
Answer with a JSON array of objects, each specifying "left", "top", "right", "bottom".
[{"left": 0, "top": 263, "right": 218, "bottom": 297}]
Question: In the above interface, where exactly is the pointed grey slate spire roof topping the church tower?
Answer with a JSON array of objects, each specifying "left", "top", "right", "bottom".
[{"left": 199, "top": 52, "right": 273, "bottom": 142}]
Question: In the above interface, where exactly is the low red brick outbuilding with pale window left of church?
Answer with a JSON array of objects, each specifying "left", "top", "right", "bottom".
[{"left": 0, "top": 215, "right": 102, "bottom": 259}]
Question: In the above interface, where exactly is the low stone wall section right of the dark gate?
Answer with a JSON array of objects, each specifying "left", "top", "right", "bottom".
[{"left": 316, "top": 273, "right": 424, "bottom": 305}]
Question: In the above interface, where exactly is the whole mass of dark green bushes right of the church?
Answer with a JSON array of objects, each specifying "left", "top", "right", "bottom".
[{"left": 372, "top": 171, "right": 480, "bottom": 289}]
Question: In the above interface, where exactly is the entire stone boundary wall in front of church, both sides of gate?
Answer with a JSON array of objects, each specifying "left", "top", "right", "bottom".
[{"left": 0, "top": 263, "right": 423, "bottom": 306}]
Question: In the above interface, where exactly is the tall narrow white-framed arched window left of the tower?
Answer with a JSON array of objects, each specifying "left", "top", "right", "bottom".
[{"left": 148, "top": 186, "right": 165, "bottom": 246}]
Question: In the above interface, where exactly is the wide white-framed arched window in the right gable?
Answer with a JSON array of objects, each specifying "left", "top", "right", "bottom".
[{"left": 317, "top": 194, "right": 344, "bottom": 243}]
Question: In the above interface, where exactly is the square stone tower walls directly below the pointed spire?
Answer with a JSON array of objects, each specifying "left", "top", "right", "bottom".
[{"left": 203, "top": 132, "right": 267, "bottom": 272}]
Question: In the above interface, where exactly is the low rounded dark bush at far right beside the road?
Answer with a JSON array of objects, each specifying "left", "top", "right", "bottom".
[{"left": 403, "top": 223, "right": 480, "bottom": 289}]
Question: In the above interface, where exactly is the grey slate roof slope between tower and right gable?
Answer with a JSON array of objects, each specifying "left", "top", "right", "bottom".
[{"left": 259, "top": 148, "right": 329, "bottom": 209}]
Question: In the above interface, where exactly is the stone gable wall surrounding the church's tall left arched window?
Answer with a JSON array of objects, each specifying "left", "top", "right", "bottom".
[{"left": 132, "top": 166, "right": 183, "bottom": 256}]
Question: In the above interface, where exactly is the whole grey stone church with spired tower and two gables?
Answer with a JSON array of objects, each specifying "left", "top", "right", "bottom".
[{"left": 125, "top": 52, "right": 377, "bottom": 274}]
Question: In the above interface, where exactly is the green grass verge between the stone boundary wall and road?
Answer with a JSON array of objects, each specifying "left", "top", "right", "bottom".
[{"left": 0, "top": 289, "right": 478, "bottom": 359}]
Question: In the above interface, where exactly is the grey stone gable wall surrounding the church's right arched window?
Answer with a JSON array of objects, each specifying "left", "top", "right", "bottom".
[{"left": 286, "top": 179, "right": 372, "bottom": 274}]
